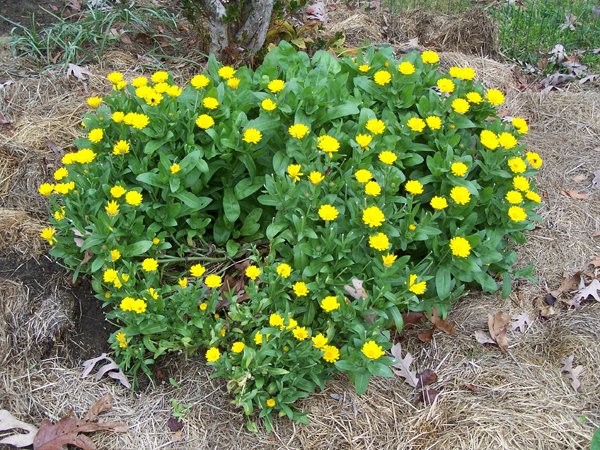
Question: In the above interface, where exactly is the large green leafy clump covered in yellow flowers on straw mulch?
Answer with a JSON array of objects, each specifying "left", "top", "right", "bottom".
[{"left": 40, "top": 42, "right": 542, "bottom": 426}]
